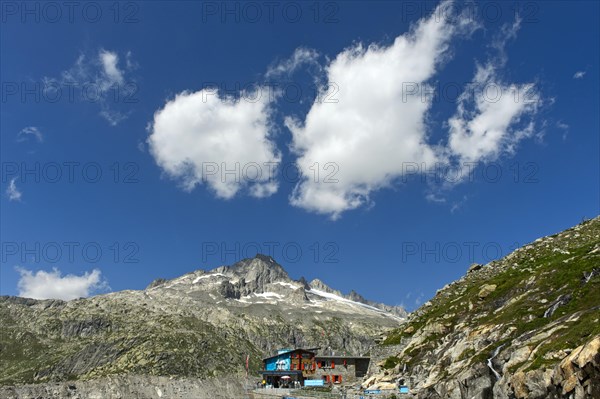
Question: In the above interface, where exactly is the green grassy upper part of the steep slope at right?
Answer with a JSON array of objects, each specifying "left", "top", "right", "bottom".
[{"left": 383, "top": 218, "right": 600, "bottom": 376}]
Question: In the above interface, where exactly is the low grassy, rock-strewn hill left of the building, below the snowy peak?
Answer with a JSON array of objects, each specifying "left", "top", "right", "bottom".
[{"left": 0, "top": 298, "right": 262, "bottom": 385}]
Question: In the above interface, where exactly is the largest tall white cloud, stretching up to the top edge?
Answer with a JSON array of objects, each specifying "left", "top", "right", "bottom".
[{"left": 286, "top": 3, "right": 473, "bottom": 219}]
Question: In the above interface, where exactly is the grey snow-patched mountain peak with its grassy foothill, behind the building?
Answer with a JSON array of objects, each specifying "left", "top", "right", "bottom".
[{"left": 0, "top": 255, "right": 404, "bottom": 399}]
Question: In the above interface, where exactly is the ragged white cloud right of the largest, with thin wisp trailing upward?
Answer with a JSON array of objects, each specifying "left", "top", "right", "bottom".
[{"left": 448, "top": 18, "right": 542, "bottom": 163}]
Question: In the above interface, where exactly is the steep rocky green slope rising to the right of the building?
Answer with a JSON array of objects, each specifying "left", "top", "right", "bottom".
[{"left": 363, "top": 217, "right": 600, "bottom": 399}]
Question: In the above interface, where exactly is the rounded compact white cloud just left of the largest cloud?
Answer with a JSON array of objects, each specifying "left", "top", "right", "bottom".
[{"left": 148, "top": 88, "right": 281, "bottom": 199}]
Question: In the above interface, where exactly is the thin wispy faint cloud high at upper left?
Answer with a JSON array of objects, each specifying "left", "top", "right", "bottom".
[{"left": 44, "top": 49, "right": 137, "bottom": 126}]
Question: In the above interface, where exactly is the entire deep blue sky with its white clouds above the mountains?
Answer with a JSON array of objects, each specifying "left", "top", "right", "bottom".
[{"left": 0, "top": 1, "right": 600, "bottom": 309}]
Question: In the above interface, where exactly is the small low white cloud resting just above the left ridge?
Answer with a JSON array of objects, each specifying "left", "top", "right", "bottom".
[{"left": 17, "top": 268, "right": 108, "bottom": 301}]
